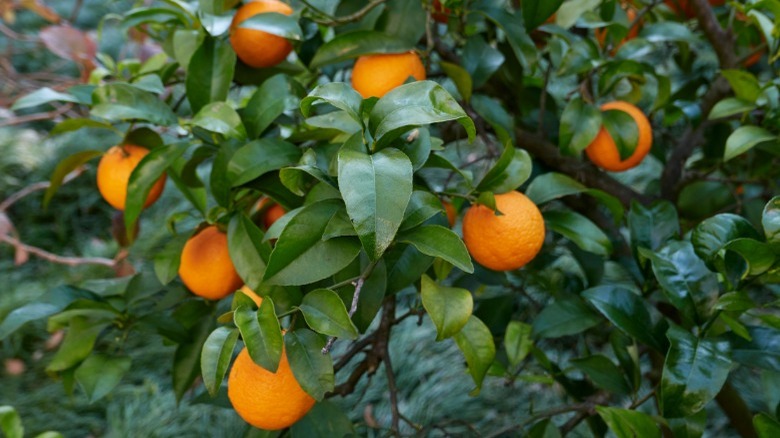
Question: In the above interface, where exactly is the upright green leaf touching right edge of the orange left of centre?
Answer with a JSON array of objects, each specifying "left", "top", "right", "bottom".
[{"left": 228, "top": 214, "right": 271, "bottom": 290}]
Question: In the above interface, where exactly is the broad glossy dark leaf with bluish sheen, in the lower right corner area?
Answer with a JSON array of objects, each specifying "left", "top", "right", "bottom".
[{"left": 659, "top": 325, "right": 732, "bottom": 418}]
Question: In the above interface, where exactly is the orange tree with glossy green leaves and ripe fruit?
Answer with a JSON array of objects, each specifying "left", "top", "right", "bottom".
[{"left": 0, "top": 0, "right": 780, "bottom": 437}]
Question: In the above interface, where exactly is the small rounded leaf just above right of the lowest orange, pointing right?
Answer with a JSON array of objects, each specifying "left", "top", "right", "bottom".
[{"left": 298, "top": 289, "right": 358, "bottom": 339}]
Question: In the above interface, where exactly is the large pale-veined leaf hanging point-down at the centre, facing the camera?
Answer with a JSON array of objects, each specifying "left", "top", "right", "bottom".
[{"left": 338, "top": 141, "right": 413, "bottom": 260}]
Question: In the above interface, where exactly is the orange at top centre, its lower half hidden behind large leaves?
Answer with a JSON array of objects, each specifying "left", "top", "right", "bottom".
[{"left": 352, "top": 52, "right": 425, "bottom": 99}]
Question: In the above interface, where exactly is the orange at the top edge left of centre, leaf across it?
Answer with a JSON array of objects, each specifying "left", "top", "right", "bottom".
[{"left": 230, "top": 0, "right": 293, "bottom": 68}]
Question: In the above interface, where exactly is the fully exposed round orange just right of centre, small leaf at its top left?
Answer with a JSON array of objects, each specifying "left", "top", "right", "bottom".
[{"left": 463, "top": 191, "right": 545, "bottom": 271}]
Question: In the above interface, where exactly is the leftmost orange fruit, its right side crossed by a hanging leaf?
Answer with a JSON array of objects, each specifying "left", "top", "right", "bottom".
[{"left": 97, "top": 144, "right": 165, "bottom": 211}]
